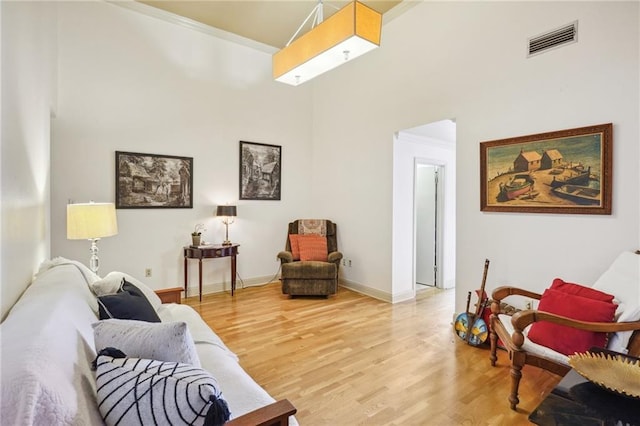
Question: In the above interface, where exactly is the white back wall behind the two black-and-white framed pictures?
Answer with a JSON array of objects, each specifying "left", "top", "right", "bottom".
[{"left": 51, "top": 2, "right": 312, "bottom": 294}]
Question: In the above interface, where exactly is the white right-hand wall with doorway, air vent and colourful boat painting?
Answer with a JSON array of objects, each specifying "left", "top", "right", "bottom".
[{"left": 313, "top": 2, "right": 640, "bottom": 311}]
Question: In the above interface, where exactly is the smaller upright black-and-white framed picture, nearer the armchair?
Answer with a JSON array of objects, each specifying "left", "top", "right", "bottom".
[{"left": 240, "top": 141, "right": 282, "bottom": 200}]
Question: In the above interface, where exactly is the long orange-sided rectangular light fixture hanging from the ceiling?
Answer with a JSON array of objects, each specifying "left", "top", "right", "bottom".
[{"left": 273, "top": 0, "right": 382, "bottom": 86}]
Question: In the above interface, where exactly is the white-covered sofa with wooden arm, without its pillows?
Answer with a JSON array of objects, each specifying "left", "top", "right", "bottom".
[{"left": 0, "top": 258, "right": 297, "bottom": 425}]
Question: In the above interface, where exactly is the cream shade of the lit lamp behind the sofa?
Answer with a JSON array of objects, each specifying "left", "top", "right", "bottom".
[{"left": 67, "top": 203, "right": 118, "bottom": 240}]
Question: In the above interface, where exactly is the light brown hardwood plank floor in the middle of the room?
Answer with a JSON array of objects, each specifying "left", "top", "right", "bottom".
[{"left": 183, "top": 283, "right": 560, "bottom": 425}]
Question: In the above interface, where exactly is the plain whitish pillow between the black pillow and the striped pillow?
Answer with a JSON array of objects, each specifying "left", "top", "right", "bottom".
[{"left": 93, "top": 319, "right": 200, "bottom": 367}]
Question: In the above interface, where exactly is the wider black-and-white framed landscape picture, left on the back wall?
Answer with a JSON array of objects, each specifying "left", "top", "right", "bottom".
[{"left": 116, "top": 151, "right": 193, "bottom": 209}]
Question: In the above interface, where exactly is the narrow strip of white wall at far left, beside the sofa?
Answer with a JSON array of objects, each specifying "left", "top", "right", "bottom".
[{"left": 0, "top": 2, "right": 55, "bottom": 319}]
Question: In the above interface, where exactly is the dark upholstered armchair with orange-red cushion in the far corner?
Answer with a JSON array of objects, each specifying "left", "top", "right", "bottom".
[{"left": 278, "top": 219, "right": 342, "bottom": 296}]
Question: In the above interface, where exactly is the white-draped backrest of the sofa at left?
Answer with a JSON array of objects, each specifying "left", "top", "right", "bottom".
[{"left": 0, "top": 264, "right": 102, "bottom": 425}]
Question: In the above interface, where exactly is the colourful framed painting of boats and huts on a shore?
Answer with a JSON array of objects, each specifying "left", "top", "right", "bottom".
[{"left": 480, "top": 123, "right": 613, "bottom": 214}]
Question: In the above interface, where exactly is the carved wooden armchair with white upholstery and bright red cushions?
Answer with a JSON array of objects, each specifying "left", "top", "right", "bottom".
[{"left": 489, "top": 252, "right": 640, "bottom": 410}]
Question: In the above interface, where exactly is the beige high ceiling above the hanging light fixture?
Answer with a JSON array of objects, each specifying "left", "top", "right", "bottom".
[{"left": 138, "top": 0, "right": 402, "bottom": 49}]
